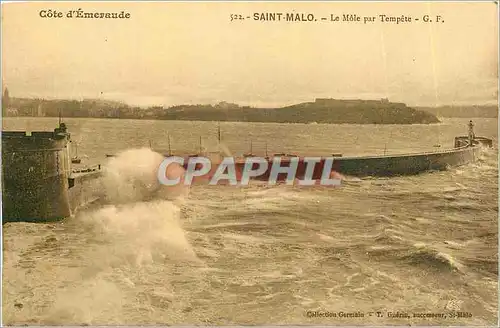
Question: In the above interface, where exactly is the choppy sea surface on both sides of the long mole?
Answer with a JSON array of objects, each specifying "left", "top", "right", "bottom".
[{"left": 3, "top": 118, "right": 498, "bottom": 325}]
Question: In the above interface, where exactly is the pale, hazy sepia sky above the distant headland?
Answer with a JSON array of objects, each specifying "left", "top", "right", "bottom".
[{"left": 2, "top": 2, "right": 498, "bottom": 106}]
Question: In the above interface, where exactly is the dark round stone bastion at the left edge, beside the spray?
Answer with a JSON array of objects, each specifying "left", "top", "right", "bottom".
[{"left": 2, "top": 123, "right": 100, "bottom": 222}]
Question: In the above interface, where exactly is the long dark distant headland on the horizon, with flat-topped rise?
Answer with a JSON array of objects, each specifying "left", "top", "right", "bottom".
[{"left": 2, "top": 90, "right": 439, "bottom": 124}]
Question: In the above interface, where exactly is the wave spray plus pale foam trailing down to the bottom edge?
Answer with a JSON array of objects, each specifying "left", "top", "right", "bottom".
[{"left": 42, "top": 149, "right": 201, "bottom": 325}]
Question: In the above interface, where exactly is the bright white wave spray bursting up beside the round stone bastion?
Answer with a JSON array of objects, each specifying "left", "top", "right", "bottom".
[{"left": 86, "top": 148, "right": 196, "bottom": 264}]
